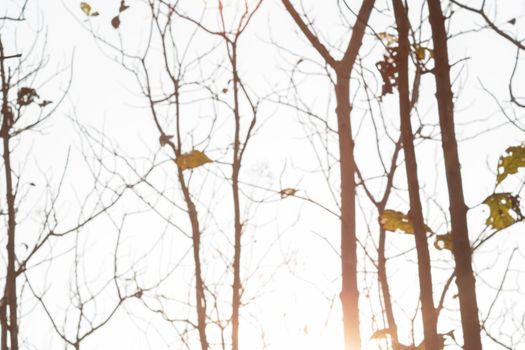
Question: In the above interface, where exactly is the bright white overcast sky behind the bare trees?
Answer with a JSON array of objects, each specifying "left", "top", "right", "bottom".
[{"left": 0, "top": 0, "right": 525, "bottom": 350}]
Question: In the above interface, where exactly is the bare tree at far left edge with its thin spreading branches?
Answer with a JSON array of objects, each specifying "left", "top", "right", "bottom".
[{"left": 0, "top": 1, "right": 140, "bottom": 350}]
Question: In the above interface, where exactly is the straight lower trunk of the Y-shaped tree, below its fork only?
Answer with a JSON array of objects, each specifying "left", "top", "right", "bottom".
[{"left": 335, "top": 74, "right": 361, "bottom": 350}]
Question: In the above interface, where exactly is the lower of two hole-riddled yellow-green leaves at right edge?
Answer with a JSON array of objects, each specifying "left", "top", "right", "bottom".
[{"left": 483, "top": 193, "right": 523, "bottom": 230}]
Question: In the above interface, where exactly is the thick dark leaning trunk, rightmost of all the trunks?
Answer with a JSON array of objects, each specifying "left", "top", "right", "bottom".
[{"left": 428, "top": 0, "right": 482, "bottom": 350}]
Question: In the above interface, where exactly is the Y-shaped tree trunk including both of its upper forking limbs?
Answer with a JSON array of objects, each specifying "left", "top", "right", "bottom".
[{"left": 282, "top": 0, "right": 375, "bottom": 350}]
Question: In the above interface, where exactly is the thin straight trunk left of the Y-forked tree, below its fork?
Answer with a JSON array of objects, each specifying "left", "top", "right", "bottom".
[{"left": 231, "top": 42, "right": 242, "bottom": 350}]
